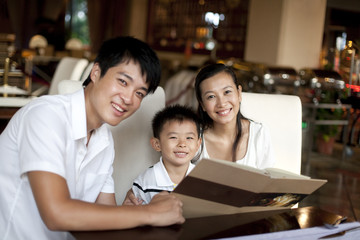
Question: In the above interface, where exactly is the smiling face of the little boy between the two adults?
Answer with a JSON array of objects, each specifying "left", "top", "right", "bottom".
[{"left": 151, "top": 120, "right": 201, "bottom": 167}]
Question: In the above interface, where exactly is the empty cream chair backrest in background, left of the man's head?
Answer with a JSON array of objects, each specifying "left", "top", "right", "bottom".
[{"left": 49, "top": 57, "right": 89, "bottom": 95}]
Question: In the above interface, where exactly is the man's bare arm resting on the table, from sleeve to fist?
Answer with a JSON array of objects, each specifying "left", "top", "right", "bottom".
[{"left": 27, "top": 171, "right": 185, "bottom": 231}]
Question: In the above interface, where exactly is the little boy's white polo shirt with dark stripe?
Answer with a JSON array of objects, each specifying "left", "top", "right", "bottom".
[{"left": 132, "top": 157, "right": 195, "bottom": 204}]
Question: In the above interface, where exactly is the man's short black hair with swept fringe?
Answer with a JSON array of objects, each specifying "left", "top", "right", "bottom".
[{"left": 83, "top": 36, "right": 161, "bottom": 93}]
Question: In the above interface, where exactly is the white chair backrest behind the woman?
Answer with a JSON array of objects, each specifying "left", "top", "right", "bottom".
[{"left": 241, "top": 92, "right": 302, "bottom": 174}]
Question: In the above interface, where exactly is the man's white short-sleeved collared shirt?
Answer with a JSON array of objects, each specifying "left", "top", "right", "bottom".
[{"left": 0, "top": 90, "right": 114, "bottom": 239}]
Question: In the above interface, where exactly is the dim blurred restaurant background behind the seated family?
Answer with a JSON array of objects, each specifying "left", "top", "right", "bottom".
[{"left": 0, "top": 0, "right": 360, "bottom": 238}]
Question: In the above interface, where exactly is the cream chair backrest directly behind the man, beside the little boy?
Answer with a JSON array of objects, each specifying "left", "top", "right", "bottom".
[{"left": 59, "top": 80, "right": 165, "bottom": 204}]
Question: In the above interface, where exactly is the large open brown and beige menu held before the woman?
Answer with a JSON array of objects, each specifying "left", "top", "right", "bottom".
[{"left": 173, "top": 159, "right": 327, "bottom": 218}]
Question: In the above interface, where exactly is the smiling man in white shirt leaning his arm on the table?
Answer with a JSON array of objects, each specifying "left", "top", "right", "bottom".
[{"left": 0, "top": 37, "right": 184, "bottom": 239}]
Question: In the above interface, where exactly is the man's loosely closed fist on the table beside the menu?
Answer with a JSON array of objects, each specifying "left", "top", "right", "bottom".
[{"left": 146, "top": 191, "right": 185, "bottom": 226}]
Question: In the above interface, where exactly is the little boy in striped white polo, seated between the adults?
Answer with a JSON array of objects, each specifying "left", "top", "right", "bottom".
[{"left": 132, "top": 105, "right": 201, "bottom": 204}]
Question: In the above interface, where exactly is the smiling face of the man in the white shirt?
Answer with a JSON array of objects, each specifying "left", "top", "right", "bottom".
[{"left": 85, "top": 61, "right": 148, "bottom": 129}]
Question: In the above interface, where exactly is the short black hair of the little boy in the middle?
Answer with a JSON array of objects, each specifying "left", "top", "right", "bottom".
[{"left": 152, "top": 104, "right": 201, "bottom": 138}]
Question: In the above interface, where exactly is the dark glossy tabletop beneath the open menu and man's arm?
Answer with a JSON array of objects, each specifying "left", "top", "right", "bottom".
[{"left": 72, "top": 207, "right": 353, "bottom": 240}]
